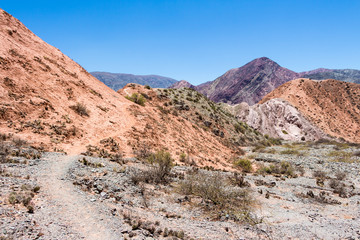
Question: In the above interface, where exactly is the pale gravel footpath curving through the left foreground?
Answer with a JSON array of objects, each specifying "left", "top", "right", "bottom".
[{"left": 35, "top": 154, "right": 119, "bottom": 240}]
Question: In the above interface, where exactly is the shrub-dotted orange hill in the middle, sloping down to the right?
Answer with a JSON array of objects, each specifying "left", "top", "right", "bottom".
[{"left": 118, "top": 84, "right": 274, "bottom": 167}]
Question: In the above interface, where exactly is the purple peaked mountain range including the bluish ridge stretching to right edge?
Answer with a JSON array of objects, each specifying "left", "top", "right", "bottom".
[{"left": 170, "top": 57, "right": 360, "bottom": 105}]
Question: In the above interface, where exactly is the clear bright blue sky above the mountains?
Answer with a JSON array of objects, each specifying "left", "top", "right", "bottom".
[{"left": 0, "top": 0, "right": 360, "bottom": 84}]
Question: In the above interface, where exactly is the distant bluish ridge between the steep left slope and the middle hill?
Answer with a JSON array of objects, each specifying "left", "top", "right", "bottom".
[{"left": 91, "top": 72, "right": 177, "bottom": 91}]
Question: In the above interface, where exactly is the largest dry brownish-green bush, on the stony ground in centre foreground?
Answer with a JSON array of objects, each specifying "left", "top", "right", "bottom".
[{"left": 178, "top": 171, "right": 254, "bottom": 221}]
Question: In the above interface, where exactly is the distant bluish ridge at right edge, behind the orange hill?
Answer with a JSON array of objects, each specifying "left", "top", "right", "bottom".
[{"left": 300, "top": 68, "right": 360, "bottom": 84}]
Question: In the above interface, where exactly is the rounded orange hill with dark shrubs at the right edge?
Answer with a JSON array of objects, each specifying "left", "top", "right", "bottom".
[{"left": 260, "top": 79, "right": 360, "bottom": 142}]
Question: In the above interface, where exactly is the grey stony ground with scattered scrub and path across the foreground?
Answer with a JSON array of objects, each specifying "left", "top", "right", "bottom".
[{"left": 0, "top": 138, "right": 360, "bottom": 239}]
